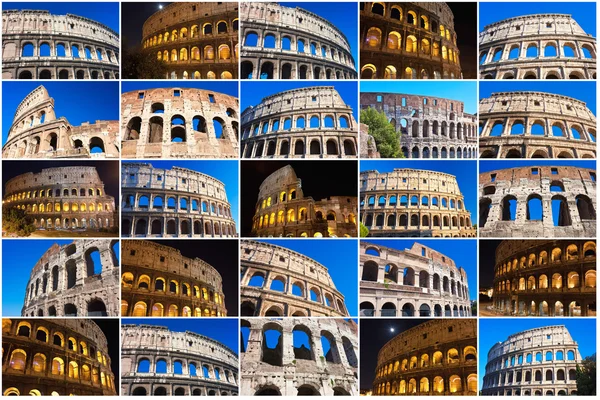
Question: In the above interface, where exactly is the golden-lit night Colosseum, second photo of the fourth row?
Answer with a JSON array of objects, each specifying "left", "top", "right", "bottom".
[{"left": 121, "top": 240, "right": 227, "bottom": 317}]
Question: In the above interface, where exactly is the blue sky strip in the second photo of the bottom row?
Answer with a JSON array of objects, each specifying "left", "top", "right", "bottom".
[{"left": 121, "top": 318, "right": 239, "bottom": 354}]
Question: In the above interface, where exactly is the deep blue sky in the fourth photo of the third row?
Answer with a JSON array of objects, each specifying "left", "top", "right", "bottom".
[{"left": 359, "top": 160, "right": 477, "bottom": 224}]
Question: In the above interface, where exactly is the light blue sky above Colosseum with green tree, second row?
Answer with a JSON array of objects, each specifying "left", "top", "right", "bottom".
[{"left": 360, "top": 81, "right": 477, "bottom": 114}]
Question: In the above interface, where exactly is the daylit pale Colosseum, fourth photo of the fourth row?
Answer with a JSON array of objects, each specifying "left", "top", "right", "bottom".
[{"left": 359, "top": 241, "right": 471, "bottom": 317}]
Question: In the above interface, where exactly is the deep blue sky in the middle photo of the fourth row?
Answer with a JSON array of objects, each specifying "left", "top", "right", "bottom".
[{"left": 256, "top": 239, "right": 358, "bottom": 317}]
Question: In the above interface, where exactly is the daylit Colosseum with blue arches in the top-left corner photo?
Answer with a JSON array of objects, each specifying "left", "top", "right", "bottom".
[{"left": 2, "top": 8, "right": 120, "bottom": 79}]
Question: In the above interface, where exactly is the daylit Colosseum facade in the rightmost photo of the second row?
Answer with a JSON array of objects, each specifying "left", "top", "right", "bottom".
[{"left": 479, "top": 92, "right": 596, "bottom": 158}]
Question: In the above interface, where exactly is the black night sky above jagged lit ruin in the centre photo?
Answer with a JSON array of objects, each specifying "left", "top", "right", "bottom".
[{"left": 240, "top": 160, "right": 358, "bottom": 237}]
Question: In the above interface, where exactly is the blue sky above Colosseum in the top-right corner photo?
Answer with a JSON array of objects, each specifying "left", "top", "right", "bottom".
[{"left": 479, "top": 1, "right": 596, "bottom": 37}]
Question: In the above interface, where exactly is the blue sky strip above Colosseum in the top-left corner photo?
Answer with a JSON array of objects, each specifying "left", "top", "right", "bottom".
[{"left": 2, "top": 1, "right": 119, "bottom": 33}]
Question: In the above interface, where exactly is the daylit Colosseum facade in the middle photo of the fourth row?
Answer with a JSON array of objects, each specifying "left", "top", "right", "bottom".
[{"left": 241, "top": 240, "right": 349, "bottom": 317}]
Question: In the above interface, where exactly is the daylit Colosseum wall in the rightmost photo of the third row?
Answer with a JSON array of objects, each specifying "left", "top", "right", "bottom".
[{"left": 479, "top": 165, "right": 596, "bottom": 238}]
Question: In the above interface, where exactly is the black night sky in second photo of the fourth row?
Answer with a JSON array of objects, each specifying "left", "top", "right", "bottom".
[{"left": 143, "top": 240, "right": 240, "bottom": 317}]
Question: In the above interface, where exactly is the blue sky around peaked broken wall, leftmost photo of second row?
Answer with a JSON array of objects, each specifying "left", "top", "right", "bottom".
[{"left": 2, "top": 81, "right": 120, "bottom": 144}]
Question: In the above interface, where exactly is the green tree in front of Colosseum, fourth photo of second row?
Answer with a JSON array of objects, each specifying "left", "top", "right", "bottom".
[{"left": 360, "top": 107, "right": 404, "bottom": 158}]
